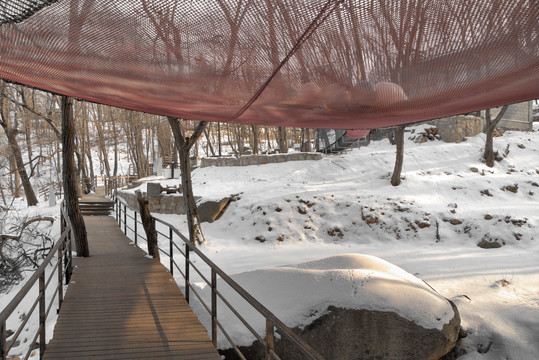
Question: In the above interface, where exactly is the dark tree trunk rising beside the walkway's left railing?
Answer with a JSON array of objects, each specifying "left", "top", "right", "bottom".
[{"left": 61, "top": 96, "right": 90, "bottom": 257}]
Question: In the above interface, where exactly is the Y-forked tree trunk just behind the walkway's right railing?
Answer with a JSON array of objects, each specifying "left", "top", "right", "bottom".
[{"left": 168, "top": 117, "right": 208, "bottom": 244}]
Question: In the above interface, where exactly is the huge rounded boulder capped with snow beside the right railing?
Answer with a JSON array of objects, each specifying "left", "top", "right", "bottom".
[{"left": 209, "top": 254, "right": 460, "bottom": 359}]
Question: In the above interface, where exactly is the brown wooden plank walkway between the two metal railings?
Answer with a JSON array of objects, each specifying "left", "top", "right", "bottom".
[{"left": 44, "top": 211, "right": 220, "bottom": 360}]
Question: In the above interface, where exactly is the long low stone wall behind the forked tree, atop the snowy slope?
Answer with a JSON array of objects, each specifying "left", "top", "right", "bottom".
[{"left": 200, "top": 152, "right": 322, "bottom": 167}]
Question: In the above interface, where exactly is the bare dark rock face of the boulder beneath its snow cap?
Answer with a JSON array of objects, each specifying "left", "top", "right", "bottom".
[{"left": 221, "top": 302, "right": 460, "bottom": 360}]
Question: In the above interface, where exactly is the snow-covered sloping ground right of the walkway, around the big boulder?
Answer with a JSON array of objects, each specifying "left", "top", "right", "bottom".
[{"left": 146, "top": 124, "right": 539, "bottom": 359}]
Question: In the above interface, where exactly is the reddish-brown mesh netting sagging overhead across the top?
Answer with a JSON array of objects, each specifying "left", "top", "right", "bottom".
[{"left": 0, "top": 0, "right": 539, "bottom": 129}]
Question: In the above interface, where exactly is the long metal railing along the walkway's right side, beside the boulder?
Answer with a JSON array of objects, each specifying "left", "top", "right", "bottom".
[{"left": 114, "top": 197, "right": 324, "bottom": 360}]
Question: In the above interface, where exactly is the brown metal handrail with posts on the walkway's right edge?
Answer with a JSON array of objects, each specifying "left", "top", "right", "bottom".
[{"left": 114, "top": 196, "right": 324, "bottom": 360}]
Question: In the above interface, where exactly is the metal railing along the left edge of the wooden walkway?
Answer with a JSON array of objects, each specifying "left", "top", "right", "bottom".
[{"left": 0, "top": 204, "right": 73, "bottom": 360}]
